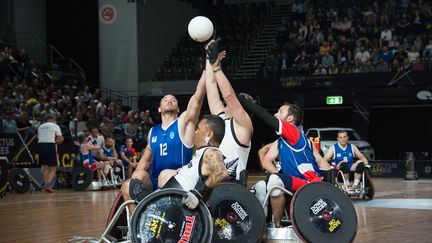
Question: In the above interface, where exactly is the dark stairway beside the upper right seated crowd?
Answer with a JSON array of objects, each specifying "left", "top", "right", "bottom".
[{"left": 234, "top": 4, "right": 291, "bottom": 79}]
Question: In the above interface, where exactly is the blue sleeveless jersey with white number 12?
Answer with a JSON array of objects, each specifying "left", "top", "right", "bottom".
[{"left": 149, "top": 119, "right": 193, "bottom": 178}]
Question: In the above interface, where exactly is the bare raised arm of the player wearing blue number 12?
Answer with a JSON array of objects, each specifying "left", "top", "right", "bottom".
[{"left": 179, "top": 71, "right": 206, "bottom": 146}]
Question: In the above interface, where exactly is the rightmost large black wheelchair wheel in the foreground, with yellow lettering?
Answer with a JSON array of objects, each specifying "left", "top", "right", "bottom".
[{"left": 290, "top": 182, "right": 357, "bottom": 242}]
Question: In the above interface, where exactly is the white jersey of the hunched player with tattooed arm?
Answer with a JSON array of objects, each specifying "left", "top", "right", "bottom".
[{"left": 174, "top": 147, "right": 218, "bottom": 191}]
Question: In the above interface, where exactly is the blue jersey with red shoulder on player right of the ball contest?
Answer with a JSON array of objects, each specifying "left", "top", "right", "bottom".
[{"left": 278, "top": 123, "right": 320, "bottom": 180}]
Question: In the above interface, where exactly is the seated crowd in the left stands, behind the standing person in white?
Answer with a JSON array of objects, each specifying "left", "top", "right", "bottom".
[{"left": 0, "top": 43, "right": 153, "bottom": 139}]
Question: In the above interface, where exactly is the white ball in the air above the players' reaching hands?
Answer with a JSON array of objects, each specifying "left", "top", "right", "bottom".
[{"left": 188, "top": 16, "right": 213, "bottom": 42}]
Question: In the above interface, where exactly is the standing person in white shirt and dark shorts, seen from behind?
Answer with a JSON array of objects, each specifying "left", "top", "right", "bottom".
[{"left": 38, "top": 113, "right": 64, "bottom": 193}]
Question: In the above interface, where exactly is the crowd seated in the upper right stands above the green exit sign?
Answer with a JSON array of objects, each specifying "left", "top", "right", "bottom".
[{"left": 262, "top": 0, "right": 432, "bottom": 77}]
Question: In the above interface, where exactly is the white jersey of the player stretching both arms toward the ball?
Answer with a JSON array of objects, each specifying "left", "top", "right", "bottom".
[{"left": 219, "top": 114, "right": 251, "bottom": 180}]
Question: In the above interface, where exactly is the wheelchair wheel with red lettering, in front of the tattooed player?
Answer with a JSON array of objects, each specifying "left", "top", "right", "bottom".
[{"left": 131, "top": 189, "right": 213, "bottom": 243}]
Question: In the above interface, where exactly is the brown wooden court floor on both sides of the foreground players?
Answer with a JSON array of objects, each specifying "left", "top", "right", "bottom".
[{"left": 0, "top": 176, "right": 432, "bottom": 243}]
